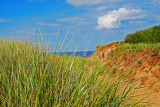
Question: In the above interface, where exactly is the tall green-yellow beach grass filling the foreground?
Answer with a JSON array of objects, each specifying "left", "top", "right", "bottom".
[{"left": 0, "top": 39, "right": 141, "bottom": 107}]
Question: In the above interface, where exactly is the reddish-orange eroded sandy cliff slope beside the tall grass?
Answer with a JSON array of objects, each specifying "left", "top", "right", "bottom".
[{"left": 88, "top": 42, "right": 160, "bottom": 107}]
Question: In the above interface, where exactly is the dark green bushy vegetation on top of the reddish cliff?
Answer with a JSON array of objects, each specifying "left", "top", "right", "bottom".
[{"left": 124, "top": 25, "right": 160, "bottom": 43}]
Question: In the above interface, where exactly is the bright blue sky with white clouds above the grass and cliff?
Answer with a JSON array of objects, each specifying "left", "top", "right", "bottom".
[{"left": 0, "top": 0, "right": 160, "bottom": 51}]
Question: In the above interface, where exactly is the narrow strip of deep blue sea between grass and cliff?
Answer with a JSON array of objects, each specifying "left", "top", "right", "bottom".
[{"left": 60, "top": 51, "right": 94, "bottom": 58}]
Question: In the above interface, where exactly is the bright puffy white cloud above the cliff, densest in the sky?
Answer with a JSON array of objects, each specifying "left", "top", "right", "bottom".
[{"left": 96, "top": 8, "right": 141, "bottom": 29}]
